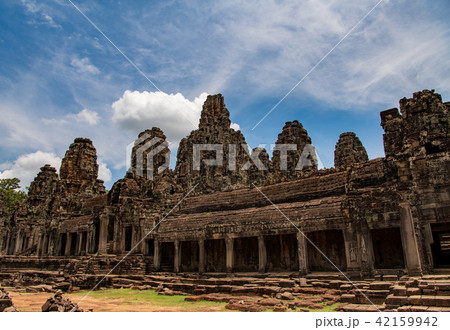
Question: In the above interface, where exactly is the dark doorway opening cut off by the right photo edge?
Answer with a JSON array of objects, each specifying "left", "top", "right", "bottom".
[{"left": 431, "top": 224, "right": 450, "bottom": 268}]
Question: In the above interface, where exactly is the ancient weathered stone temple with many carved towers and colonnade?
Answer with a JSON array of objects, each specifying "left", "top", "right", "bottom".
[{"left": 0, "top": 90, "right": 450, "bottom": 277}]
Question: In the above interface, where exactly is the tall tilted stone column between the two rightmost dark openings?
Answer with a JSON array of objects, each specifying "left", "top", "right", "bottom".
[{"left": 399, "top": 202, "right": 422, "bottom": 276}]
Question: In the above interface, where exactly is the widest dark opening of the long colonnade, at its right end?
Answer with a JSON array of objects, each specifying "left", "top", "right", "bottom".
[{"left": 307, "top": 229, "right": 347, "bottom": 272}]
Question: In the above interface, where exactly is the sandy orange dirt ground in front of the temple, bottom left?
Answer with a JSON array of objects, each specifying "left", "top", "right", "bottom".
[{"left": 9, "top": 291, "right": 226, "bottom": 312}]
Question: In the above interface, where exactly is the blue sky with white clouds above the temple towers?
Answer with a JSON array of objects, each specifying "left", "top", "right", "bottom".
[{"left": 0, "top": 0, "right": 450, "bottom": 187}]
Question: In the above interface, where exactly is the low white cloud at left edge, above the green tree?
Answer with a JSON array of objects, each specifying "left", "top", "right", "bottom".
[{"left": 0, "top": 151, "right": 61, "bottom": 188}]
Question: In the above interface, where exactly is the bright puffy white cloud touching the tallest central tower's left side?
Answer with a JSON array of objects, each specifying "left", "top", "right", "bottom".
[{"left": 112, "top": 90, "right": 208, "bottom": 143}]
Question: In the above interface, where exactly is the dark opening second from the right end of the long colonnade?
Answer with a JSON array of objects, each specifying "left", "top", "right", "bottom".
[{"left": 264, "top": 234, "right": 298, "bottom": 272}]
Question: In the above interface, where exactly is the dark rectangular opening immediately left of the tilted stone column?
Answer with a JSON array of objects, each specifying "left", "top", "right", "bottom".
[{"left": 370, "top": 228, "right": 405, "bottom": 269}]
